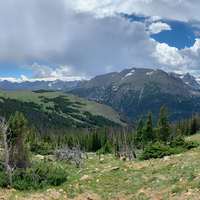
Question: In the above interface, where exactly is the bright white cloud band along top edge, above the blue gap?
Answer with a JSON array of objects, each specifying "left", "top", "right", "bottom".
[{"left": 65, "top": 0, "right": 200, "bottom": 21}]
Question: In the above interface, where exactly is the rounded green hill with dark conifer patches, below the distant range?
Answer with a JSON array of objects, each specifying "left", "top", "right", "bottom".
[{"left": 0, "top": 90, "right": 133, "bottom": 129}]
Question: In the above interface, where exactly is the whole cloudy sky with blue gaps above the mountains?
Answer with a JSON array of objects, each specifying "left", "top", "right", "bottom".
[{"left": 0, "top": 0, "right": 200, "bottom": 82}]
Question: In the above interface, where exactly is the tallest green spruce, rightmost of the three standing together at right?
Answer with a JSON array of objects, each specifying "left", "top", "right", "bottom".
[{"left": 156, "top": 104, "right": 170, "bottom": 145}]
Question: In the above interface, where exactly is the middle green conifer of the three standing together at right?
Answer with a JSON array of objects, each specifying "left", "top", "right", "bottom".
[{"left": 142, "top": 110, "right": 156, "bottom": 143}]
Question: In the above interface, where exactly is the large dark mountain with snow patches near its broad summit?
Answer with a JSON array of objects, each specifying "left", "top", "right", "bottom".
[{"left": 70, "top": 68, "right": 200, "bottom": 121}]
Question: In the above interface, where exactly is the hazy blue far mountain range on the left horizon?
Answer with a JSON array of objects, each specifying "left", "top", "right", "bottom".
[{"left": 0, "top": 80, "right": 86, "bottom": 92}]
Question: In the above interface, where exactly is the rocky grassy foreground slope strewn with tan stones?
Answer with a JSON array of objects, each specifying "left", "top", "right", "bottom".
[{"left": 0, "top": 133, "right": 200, "bottom": 200}]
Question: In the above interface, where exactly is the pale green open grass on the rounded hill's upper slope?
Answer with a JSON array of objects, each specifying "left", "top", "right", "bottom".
[{"left": 0, "top": 90, "right": 129, "bottom": 125}]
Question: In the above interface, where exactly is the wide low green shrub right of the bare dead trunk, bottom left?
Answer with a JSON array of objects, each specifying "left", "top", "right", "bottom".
[{"left": 12, "top": 162, "right": 68, "bottom": 190}]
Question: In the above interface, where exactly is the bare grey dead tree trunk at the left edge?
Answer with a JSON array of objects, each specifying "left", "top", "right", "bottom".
[{"left": 0, "top": 118, "right": 16, "bottom": 184}]
